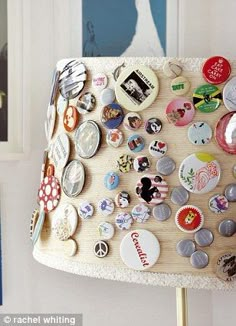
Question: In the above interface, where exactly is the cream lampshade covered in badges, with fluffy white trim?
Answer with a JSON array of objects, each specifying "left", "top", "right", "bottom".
[{"left": 31, "top": 58, "right": 236, "bottom": 289}]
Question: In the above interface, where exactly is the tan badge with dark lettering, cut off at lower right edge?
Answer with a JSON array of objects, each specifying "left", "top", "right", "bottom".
[{"left": 216, "top": 252, "right": 236, "bottom": 282}]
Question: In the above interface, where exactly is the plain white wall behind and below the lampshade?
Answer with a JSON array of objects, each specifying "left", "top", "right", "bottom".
[{"left": 0, "top": 0, "right": 236, "bottom": 326}]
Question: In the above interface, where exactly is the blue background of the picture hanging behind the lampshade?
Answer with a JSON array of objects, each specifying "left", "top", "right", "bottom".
[{"left": 82, "top": 0, "right": 166, "bottom": 57}]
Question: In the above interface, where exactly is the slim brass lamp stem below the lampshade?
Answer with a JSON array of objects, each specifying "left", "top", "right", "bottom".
[{"left": 176, "top": 288, "right": 188, "bottom": 326}]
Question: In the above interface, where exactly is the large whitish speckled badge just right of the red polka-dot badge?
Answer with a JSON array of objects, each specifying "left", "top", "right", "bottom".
[{"left": 52, "top": 204, "right": 78, "bottom": 241}]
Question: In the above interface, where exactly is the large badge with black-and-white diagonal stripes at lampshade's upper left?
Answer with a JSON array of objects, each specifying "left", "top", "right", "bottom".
[{"left": 59, "top": 60, "right": 87, "bottom": 99}]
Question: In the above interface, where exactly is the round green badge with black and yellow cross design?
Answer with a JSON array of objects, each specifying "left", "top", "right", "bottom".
[{"left": 193, "top": 84, "right": 222, "bottom": 113}]
